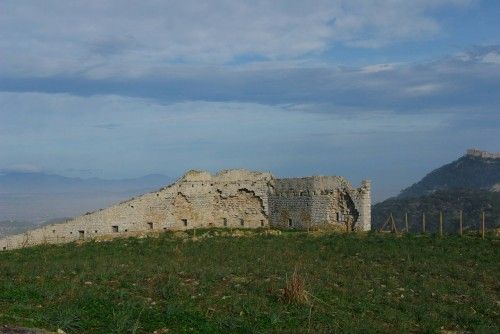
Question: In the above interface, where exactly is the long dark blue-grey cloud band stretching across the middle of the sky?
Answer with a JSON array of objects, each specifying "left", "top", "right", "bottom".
[{"left": 0, "top": 46, "right": 500, "bottom": 113}]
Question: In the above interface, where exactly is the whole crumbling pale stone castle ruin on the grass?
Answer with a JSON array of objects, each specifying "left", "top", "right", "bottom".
[{"left": 0, "top": 170, "right": 371, "bottom": 251}]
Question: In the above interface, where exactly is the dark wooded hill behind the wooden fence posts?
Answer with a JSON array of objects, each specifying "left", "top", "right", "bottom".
[{"left": 372, "top": 150, "right": 500, "bottom": 232}]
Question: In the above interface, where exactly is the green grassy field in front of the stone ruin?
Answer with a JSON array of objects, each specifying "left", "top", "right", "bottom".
[{"left": 0, "top": 230, "right": 500, "bottom": 333}]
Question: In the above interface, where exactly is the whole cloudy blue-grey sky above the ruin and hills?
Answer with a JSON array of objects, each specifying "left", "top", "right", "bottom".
[{"left": 0, "top": 0, "right": 500, "bottom": 201}]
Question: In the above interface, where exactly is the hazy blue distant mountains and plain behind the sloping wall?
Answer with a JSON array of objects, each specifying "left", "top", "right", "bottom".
[{"left": 0, "top": 172, "right": 174, "bottom": 235}]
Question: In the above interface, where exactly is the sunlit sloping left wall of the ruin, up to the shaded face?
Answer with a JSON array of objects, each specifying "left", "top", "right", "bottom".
[{"left": 0, "top": 170, "right": 272, "bottom": 250}]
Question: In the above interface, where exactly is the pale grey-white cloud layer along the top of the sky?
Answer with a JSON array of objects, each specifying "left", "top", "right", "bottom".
[{"left": 0, "top": 0, "right": 469, "bottom": 78}]
